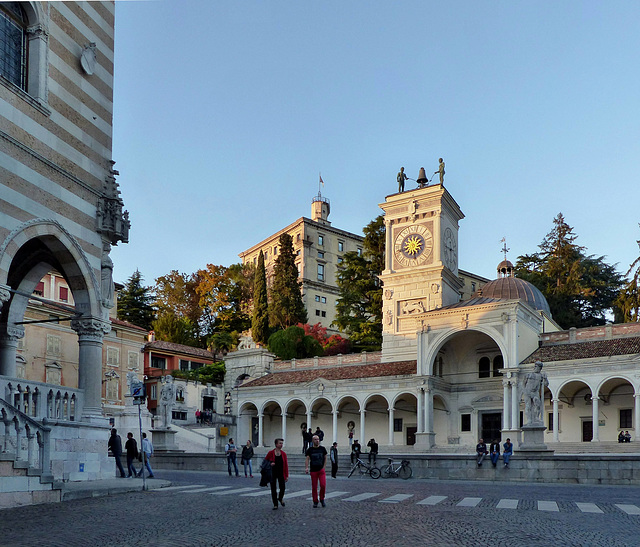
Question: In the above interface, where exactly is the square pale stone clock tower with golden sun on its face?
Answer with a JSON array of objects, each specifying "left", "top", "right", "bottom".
[{"left": 380, "top": 184, "right": 464, "bottom": 362}]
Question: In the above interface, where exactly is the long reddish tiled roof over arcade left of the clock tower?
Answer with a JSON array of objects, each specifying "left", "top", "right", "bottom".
[{"left": 241, "top": 361, "right": 417, "bottom": 388}]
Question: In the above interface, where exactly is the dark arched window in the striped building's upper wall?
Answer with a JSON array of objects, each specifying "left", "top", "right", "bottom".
[{"left": 0, "top": 2, "right": 27, "bottom": 91}]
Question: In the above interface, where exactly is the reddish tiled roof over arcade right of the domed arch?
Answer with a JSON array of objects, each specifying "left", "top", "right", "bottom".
[{"left": 522, "top": 337, "right": 640, "bottom": 363}]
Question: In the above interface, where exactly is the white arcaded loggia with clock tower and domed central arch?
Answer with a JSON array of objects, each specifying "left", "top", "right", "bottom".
[{"left": 225, "top": 184, "right": 640, "bottom": 453}]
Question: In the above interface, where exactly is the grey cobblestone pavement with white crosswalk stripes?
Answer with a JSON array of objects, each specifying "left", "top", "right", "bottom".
[{"left": 0, "top": 471, "right": 640, "bottom": 547}]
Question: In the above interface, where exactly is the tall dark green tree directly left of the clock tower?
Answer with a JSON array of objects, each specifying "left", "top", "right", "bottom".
[{"left": 333, "top": 215, "right": 385, "bottom": 351}]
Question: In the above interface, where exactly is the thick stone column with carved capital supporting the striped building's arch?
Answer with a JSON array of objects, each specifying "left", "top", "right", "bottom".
[{"left": 71, "top": 317, "right": 111, "bottom": 421}]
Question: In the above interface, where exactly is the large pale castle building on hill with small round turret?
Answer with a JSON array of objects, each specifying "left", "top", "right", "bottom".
[{"left": 239, "top": 192, "right": 364, "bottom": 334}]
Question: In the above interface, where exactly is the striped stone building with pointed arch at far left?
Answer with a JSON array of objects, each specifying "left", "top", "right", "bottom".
[{"left": 0, "top": 1, "right": 129, "bottom": 484}]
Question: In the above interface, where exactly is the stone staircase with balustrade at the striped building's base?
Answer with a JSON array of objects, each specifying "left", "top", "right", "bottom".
[{"left": 0, "top": 399, "right": 61, "bottom": 509}]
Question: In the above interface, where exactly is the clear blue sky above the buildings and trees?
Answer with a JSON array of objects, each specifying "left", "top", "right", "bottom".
[{"left": 112, "top": 0, "right": 640, "bottom": 285}]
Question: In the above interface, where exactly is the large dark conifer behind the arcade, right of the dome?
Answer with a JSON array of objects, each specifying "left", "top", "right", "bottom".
[{"left": 515, "top": 213, "right": 623, "bottom": 329}]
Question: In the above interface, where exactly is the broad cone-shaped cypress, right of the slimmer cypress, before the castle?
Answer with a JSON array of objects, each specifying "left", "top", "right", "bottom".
[{"left": 269, "top": 233, "right": 307, "bottom": 329}]
